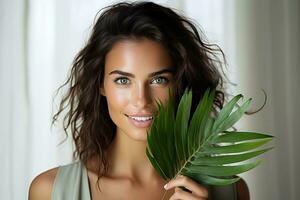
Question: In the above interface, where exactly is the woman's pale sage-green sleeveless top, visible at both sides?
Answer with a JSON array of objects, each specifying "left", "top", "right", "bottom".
[{"left": 51, "top": 161, "right": 237, "bottom": 200}]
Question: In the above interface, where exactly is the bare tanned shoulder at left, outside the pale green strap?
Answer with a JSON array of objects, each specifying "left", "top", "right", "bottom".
[{"left": 28, "top": 167, "right": 58, "bottom": 200}]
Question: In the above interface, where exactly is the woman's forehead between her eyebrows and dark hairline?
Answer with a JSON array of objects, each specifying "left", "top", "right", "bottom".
[{"left": 105, "top": 39, "right": 172, "bottom": 72}]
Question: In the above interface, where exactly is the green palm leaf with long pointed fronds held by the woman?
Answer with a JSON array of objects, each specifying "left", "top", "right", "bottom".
[{"left": 146, "top": 89, "right": 273, "bottom": 185}]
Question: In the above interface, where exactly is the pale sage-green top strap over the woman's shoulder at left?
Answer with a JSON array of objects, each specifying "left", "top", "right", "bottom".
[{"left": 51, "top": 161, "right": 91, "bottom": 200}]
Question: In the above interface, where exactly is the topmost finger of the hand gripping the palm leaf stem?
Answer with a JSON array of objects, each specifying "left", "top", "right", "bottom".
[{"left": 165, "top": 176, "right": 208, "bottom": 198}]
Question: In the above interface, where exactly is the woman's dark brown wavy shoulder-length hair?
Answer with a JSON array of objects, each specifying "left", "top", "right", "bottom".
[{"left": 53, "top": 2, "right": 226, "bottom": 180}]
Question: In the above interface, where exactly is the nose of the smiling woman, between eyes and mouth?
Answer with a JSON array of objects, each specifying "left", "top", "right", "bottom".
[{"left": 131, "top": 85, "right": 151, "bottom": 108}]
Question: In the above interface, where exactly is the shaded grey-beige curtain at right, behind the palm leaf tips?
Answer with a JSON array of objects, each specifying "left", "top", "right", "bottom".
[{"left": 235, "top": 0, "right": 300, "bottom": 199}]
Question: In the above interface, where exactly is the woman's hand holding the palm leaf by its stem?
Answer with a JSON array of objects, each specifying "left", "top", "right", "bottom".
[{"left": 164, "top": 175, "right": 208, "bottom": 200}]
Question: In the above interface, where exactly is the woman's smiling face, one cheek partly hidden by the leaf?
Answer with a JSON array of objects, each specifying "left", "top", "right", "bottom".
[{"left": 101, "top": 39, "right": 174, "bottom": 141}]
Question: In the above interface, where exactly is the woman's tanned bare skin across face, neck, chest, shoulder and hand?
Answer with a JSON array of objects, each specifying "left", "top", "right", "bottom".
[{"left": 29, "top": 39, "right": 248, "bottom": 200}]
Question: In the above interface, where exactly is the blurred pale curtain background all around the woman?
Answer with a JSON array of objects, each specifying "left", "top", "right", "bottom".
[{"left": 0, "top": 0, "right": 300, "bottom": 200}]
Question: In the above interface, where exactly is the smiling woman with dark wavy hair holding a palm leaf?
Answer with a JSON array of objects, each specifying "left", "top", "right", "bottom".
[{"left": 29, "top": 2, "right": 245, "bottom": 200}]
